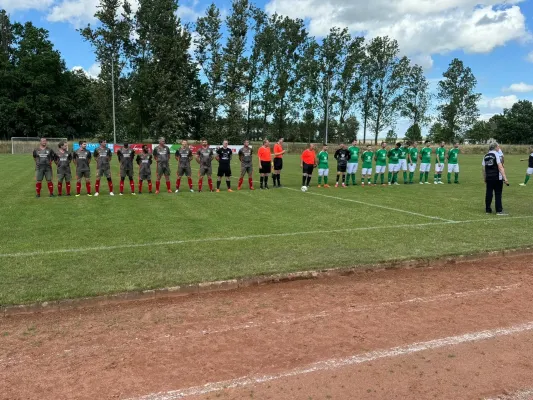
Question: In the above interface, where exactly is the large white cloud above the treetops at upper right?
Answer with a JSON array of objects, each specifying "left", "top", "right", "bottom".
[{"left": 266, "top": 0, "right": 529, "bottom": 60}]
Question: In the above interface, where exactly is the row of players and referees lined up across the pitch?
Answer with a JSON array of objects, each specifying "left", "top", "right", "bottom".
[{"left": 33, "top": 138, "right": 533, "bottom": 197}]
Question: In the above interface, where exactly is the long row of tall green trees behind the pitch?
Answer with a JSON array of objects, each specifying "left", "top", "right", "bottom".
[{"left": 0, "top": 0, "right": 516, "bottom": 142}]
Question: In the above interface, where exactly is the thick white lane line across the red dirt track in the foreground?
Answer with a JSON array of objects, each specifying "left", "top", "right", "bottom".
[{"left": 130, "top": 322, "right": 533, "bottom": 400}]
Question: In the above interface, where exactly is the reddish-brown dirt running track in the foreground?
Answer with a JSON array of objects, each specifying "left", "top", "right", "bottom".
[{"left": 0, "top": 255, "right": 533, "bottom": 400}]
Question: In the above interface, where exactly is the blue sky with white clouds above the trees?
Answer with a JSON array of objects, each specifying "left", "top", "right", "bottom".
[{"left": 0, "top": 0, "right": 533, "bottom": 134}]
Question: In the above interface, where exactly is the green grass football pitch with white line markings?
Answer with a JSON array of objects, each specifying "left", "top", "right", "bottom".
[{"left": 0, "top": 155, "right": 533, "bottom": 305}]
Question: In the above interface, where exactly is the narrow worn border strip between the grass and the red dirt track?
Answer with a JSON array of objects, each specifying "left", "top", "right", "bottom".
[{"left": 0, "top": 247, "right": 533, "bottom": 317}]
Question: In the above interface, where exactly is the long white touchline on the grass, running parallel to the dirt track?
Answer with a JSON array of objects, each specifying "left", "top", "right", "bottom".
[{"left": 0, "top": 215, "right": 533, "bottom": 259}]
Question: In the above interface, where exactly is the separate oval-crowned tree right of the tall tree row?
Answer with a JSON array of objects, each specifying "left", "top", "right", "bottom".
[{"left": 437, "top": 58, "right": 481, "bottom": 142}]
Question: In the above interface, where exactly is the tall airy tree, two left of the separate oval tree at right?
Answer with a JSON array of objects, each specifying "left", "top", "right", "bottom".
[{"left": 367, "top": 36, "right": 409, "bottom": 144}]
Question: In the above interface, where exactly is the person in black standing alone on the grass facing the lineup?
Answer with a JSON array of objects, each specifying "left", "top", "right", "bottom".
[{"left": 481, "top": 143, "right": 509, "bottom": 215}]
